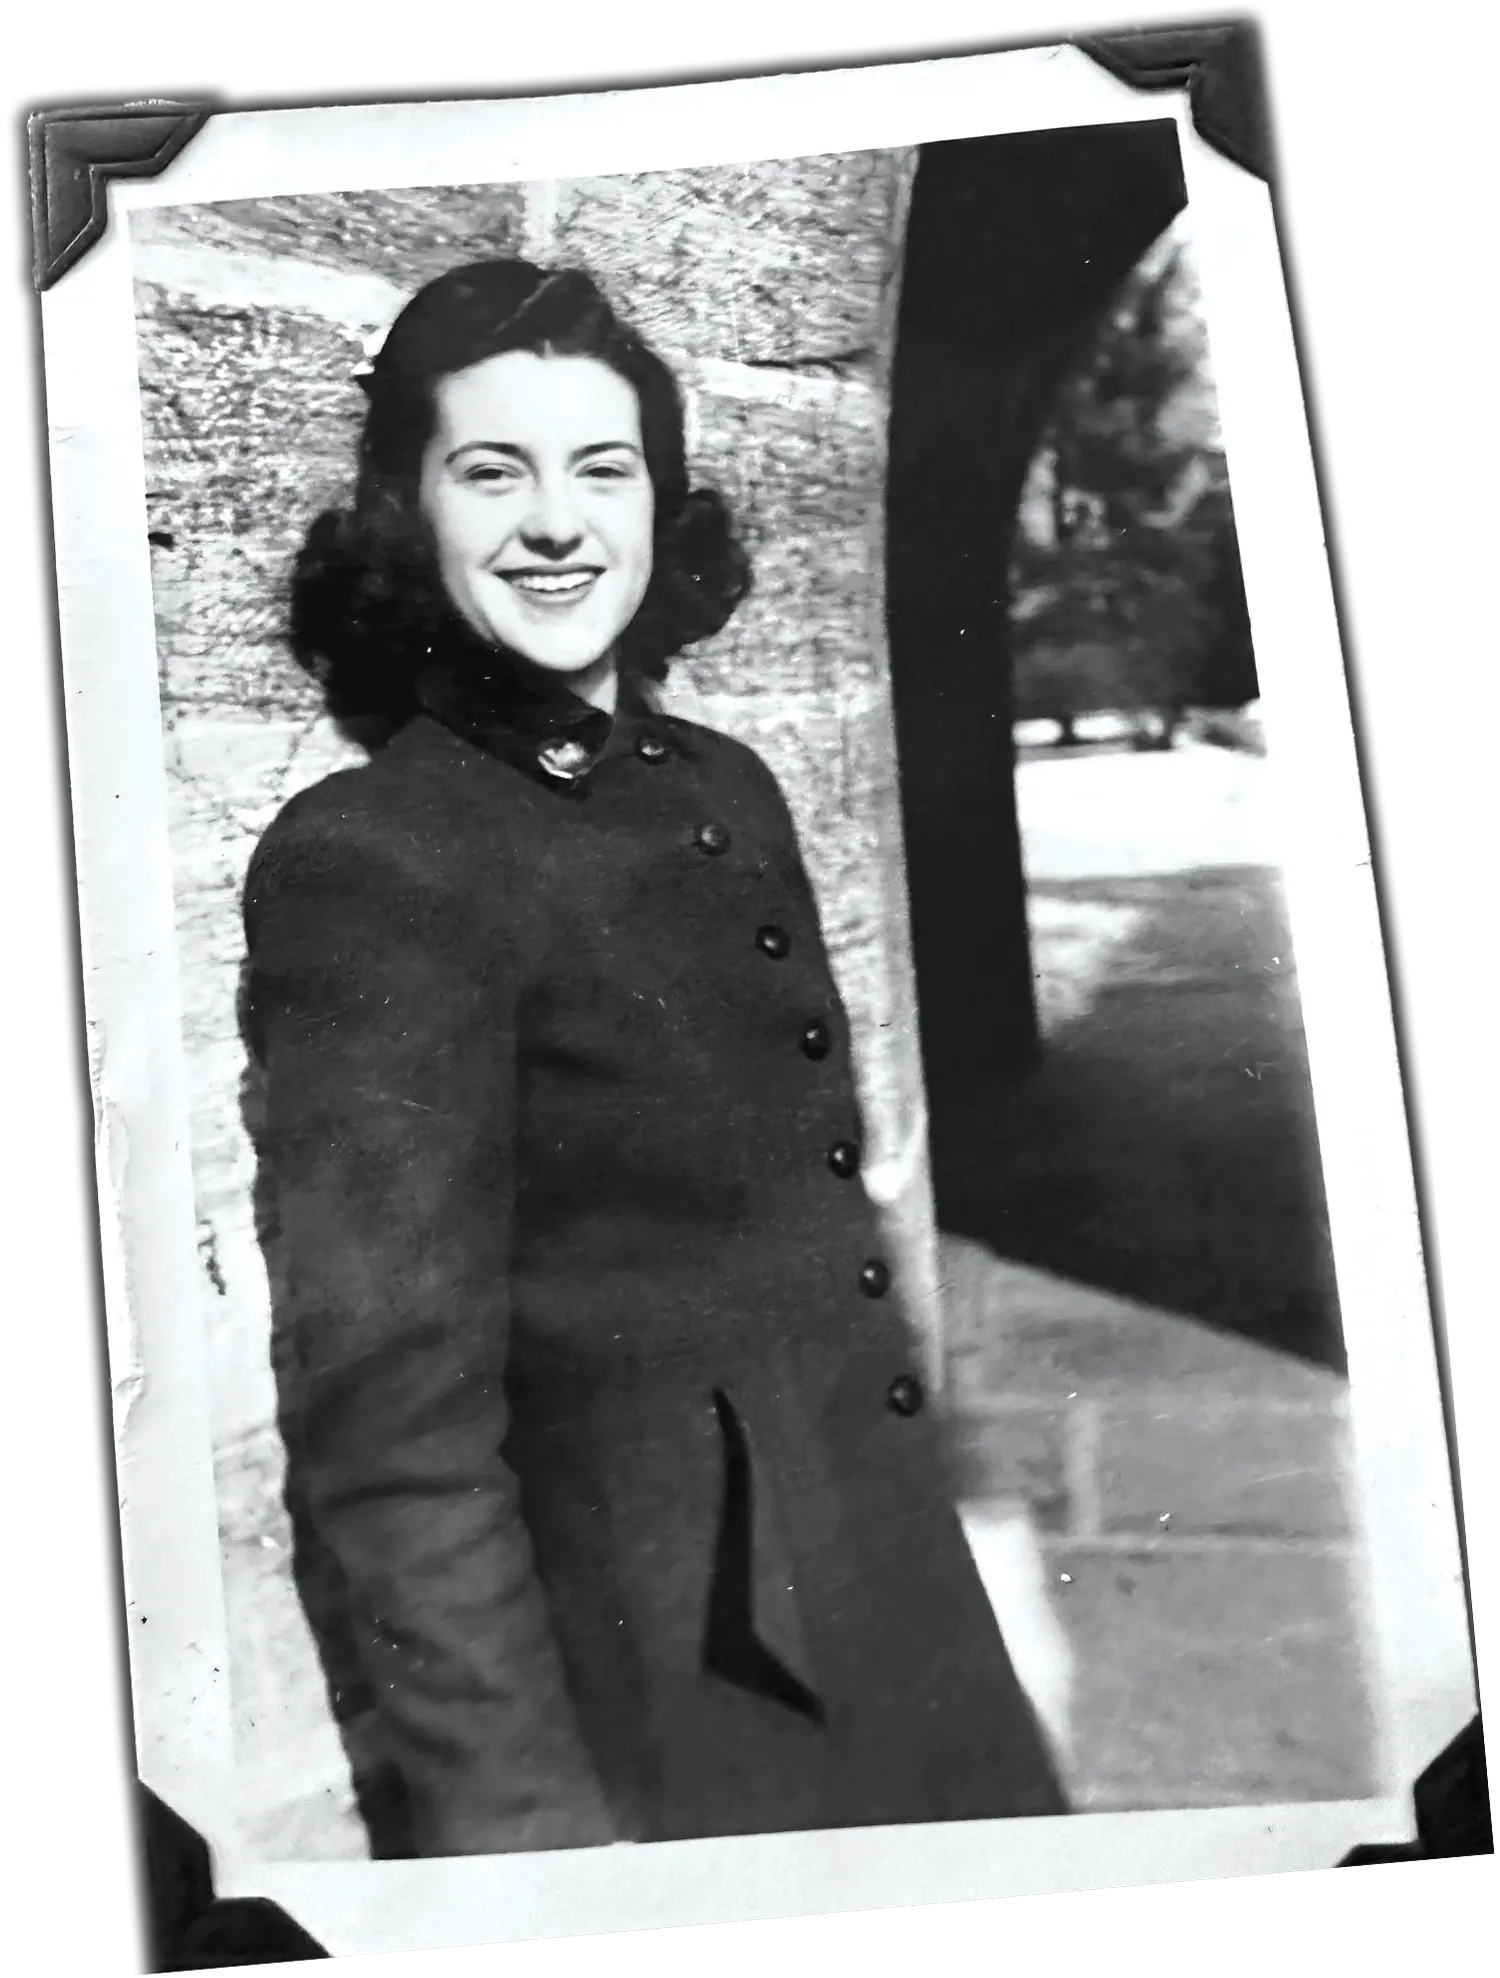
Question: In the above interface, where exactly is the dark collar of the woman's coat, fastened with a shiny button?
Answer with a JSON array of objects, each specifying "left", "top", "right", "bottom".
[{"left": 416, "top": 621, "right": 651, "bottom": 795}]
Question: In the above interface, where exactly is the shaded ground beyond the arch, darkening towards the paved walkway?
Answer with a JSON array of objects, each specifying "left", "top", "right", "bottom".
[{"left": 934, "top": 866, "right": 1344, "bottom": 1371}]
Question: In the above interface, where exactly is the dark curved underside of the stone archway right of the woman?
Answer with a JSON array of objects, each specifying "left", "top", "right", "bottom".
[{"left": 887, "top": 121, "right": 1187, "bottom": 1234}]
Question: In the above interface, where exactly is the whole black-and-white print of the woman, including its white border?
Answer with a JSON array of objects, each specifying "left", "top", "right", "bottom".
[{"left": 44, "top": 47, "right": 1474, "bottom": 1956}]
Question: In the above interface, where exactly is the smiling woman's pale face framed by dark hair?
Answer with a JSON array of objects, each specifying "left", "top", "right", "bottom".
[{"left": 420, "top": 350, "right": 655, "bottom": 674}]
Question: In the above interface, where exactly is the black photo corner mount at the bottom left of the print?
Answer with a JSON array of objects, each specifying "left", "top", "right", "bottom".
[{"left": 129, "top": 1778, "right": 334, "bottom": 1974}]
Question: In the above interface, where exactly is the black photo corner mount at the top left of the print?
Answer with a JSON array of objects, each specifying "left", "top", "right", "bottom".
[{"left": 28, "top": 101, "right": 212, "bottom": 289}]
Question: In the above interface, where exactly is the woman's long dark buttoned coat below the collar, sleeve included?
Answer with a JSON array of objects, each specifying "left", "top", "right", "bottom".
[{"left": 245, "top": 656, "right": 1061, "bottom": 1855}]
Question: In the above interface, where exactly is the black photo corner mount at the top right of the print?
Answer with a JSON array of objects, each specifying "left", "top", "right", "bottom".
[{"left": 1067, "top": 12, "right": 1272, "bottom": 180}]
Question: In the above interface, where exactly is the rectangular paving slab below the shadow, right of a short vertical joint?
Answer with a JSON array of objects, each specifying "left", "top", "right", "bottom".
[{"left": 1096, "top": 1400, "right": 1350, "bottom": 1539}]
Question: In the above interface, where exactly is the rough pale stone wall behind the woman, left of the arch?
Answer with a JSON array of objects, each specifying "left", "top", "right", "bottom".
[{"left": 131, "top": 152, "right": 936, "bottom": 1853}]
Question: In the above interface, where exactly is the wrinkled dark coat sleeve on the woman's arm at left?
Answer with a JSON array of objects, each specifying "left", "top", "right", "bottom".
[{"left": 245, "top": 799, "right": 615, "bottom": 1855}]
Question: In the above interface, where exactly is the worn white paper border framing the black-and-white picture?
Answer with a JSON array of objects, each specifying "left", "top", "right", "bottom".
[{"left": 42, "top": 47, "right": 1474, "bottom": 1958}]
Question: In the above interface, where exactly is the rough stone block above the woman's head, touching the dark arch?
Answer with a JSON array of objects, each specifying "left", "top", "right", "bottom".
[{"left": 550, "top": 150, "right": 914, "bottom": 364}]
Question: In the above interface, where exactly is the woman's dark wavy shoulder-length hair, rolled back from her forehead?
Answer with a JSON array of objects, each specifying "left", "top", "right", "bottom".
[{"left": 289, "top": 261, "right": 750, "bottom": 734}]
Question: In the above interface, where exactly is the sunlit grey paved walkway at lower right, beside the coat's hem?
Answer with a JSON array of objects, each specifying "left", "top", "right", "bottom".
[{"left": 944, "top": 1238, "right": 1373, "bottom": 1810}]
